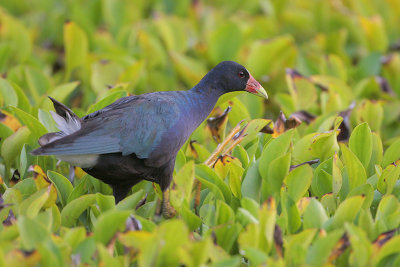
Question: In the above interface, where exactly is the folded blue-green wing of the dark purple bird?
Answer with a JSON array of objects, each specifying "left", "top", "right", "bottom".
[{"left": 36, "top": 94, "right": 180, "bottom": 158}]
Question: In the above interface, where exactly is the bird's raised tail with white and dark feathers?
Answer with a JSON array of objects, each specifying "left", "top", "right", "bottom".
[{"left": 31, "top": 96, "right": 81, "bottom": 155}]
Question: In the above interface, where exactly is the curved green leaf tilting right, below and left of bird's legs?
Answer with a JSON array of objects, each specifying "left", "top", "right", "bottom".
[{"left": 61, "top": 194, "right": 96, "bottom": 227}]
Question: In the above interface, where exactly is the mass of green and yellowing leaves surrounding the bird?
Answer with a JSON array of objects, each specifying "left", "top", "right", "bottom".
[{"left": 0, "top": 0, "right": 400, "bottom": 266}]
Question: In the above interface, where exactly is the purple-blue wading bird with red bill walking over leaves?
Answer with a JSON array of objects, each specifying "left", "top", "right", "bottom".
[{"left": 31, "top": 61, "right": 268, "bottom": 217}]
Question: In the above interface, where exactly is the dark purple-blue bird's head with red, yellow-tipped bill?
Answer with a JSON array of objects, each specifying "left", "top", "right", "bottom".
[{"left": 209, "top": 61, "right": 268, "bottom": 99}]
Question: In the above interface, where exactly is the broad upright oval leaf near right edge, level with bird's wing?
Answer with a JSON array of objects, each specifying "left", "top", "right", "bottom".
[{"left": 349, "top": 123, "right": 372, "bottom": 169}]
